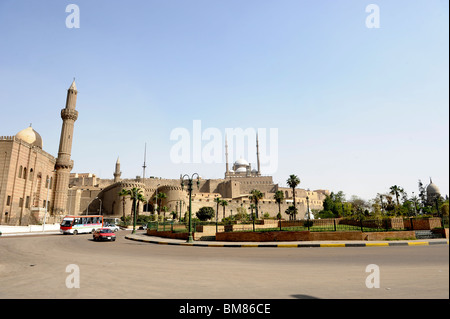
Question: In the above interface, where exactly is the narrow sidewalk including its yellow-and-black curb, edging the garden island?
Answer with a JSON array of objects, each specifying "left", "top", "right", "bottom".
[{"left": 125, "top": 233, "right": 449, "bottom": 248}]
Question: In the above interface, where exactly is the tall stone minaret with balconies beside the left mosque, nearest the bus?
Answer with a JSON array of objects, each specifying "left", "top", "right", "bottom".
[{"left": 53, "top": 79, "right": 78, "bottom": 214}]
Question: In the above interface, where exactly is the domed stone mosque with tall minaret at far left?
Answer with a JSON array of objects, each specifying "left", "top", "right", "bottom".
[{"left": 0, "top": 80, "right": 78, "bottom": 225}]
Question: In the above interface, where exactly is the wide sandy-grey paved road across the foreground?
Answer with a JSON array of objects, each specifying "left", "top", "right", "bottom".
[{"left": 0, "top": 231, "right": 449, "bottom": 299}]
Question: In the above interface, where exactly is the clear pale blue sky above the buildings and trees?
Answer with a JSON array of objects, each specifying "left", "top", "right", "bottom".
[{"left": 0, "top": 0, "right": 449, "bottom": 199}]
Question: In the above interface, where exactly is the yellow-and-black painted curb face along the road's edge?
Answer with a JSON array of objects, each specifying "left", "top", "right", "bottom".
[{"left": 125, "top": 235, "right": 449, "bottom": 248}]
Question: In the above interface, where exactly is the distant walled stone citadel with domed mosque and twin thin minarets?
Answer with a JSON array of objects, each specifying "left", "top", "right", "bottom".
[{"left": 69, "top": 134, "right": 329, "bottom": 220}]
